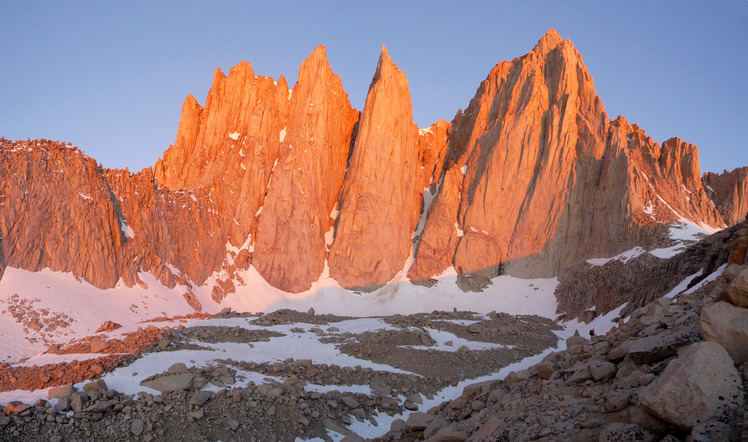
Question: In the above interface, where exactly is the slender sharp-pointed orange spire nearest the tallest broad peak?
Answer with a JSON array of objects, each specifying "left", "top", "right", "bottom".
[{"left": 329, "top": 47, "right": 421, "bottom": 287}]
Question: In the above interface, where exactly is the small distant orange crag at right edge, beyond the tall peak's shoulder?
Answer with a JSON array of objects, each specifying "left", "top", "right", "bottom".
[{"left": 701, "top": 167, "right": 748, "bottom": 225}]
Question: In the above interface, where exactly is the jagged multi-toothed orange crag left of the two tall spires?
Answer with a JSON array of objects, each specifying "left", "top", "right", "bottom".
[{"left": 153, "top": 58, "right": 291, "bottom": 247}]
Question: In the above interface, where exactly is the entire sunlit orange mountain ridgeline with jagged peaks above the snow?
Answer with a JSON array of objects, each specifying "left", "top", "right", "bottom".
[{"left": 0, "top": 30, "right": 748, "bottom": 309}]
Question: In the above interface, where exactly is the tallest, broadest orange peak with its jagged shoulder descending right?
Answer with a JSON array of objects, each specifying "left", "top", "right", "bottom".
[{"left": 409, "top": 31, "right": 724, "bottom": 279}]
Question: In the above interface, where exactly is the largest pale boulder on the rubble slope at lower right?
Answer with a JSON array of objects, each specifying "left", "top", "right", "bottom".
[{"left": 639, "top": 341, "right": 744, "bottom": 429}]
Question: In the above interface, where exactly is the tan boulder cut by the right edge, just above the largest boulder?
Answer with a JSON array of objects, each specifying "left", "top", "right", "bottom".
[{"left": 700, "top": 302, "right": 748, "bottom": 365}]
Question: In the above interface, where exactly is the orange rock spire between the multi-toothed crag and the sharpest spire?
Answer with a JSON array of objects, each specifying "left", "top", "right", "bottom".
[{"left": 253, "top": 47, "right": 358, "bottom": 292}]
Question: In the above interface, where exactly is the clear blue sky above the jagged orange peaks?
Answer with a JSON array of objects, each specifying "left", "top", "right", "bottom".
[{"left": 0, "top": 0, "right": 748, "bottom": 171}]
